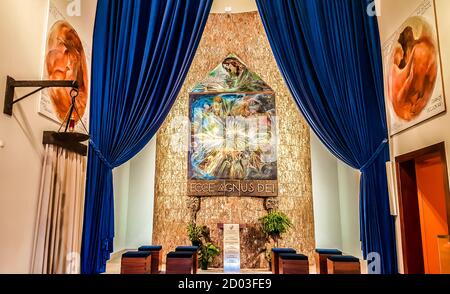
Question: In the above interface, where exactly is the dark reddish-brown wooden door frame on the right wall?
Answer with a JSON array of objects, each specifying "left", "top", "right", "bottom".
[{"left": 395, "top": 142, "right": 450, "bottom": 273}]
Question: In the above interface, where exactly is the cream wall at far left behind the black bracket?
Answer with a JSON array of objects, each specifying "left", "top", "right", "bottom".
[{"left": 0, "top": 0, "right": 96, "bottom": 273}]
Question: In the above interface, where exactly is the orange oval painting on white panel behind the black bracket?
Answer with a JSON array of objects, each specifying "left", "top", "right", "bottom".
[{"left": 39, "top": 0, "right": 93, "bottom": 129}]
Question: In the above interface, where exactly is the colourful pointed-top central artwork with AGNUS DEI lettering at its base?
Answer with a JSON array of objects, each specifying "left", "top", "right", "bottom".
[{"left": 188, "top": 55, "right": 278, "bottom": 197}]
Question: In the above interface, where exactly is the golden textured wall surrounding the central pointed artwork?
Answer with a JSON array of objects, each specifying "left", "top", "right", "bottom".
[{"left": 153, "top": 12, "right": 315, "bottom": 268}]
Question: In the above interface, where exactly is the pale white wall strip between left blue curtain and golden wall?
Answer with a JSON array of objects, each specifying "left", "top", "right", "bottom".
[{"left": 114, "top": 137, "right": 156, "bottom": 252}]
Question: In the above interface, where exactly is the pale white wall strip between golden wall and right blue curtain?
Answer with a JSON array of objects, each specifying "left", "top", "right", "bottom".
[{"left": 311, "top": 132, "right": 362, "bottom": 258}]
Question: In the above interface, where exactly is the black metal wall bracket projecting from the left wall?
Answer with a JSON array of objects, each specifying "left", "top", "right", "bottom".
[{"left": 3, "top": 76, "right": 78, "bottom": 116}]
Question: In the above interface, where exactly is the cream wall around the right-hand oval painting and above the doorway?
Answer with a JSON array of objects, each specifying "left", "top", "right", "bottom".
[{"left": 378, "top": 0, "right": 450, "bottom": 272}]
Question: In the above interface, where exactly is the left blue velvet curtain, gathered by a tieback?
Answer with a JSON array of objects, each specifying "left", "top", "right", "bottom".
[{"left": 81, "top": 0, "right": 212, "bottom": 274}]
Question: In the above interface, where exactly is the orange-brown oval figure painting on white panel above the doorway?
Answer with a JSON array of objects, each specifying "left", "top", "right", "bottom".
[{"left": 383, "top": 0, "right": 446, "bottom": 135}]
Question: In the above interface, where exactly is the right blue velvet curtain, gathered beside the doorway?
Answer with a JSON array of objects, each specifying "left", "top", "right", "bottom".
[{"left": 257, "top": 0, "right": 397, "bottom": 274}]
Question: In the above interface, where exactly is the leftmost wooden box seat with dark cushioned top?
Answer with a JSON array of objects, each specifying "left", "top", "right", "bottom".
[{"left": 120, "top": 251, "right": 152, "bottom": 275}]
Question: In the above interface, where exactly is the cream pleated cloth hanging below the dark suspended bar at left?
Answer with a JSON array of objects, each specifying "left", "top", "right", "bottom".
[{"left": 32, "top": 145, "right": 86, "bottom": 274}]
